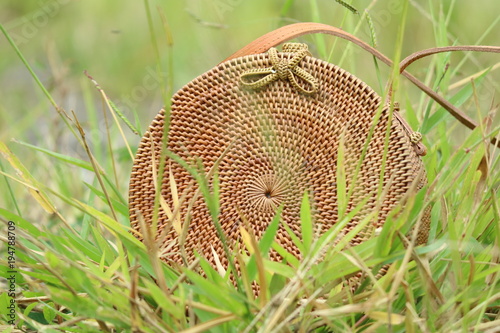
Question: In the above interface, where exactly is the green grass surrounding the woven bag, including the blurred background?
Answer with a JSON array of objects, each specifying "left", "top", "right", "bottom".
[{"left": 0, "top": 0, "right": 500, "bottom": 332}]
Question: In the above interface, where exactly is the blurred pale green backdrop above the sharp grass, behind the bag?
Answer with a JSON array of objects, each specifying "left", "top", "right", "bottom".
[{"left": 0, "top": 0, "right": 500, "bottom": 217}]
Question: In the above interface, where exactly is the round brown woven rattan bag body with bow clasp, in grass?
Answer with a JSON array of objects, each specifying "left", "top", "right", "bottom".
[{"left": 129, "top": 25, "right": 428, "bottom": 265}]
